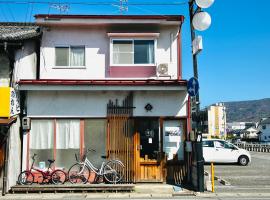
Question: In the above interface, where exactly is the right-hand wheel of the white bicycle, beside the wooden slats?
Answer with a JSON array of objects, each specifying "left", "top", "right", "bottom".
[{"left": 103, "top": 160, "right": 125, "bottom": 183}]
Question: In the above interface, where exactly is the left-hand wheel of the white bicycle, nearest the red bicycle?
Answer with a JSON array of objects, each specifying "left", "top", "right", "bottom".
[{"left": 68, "top": 163, "right": 90, "bottom": 183}]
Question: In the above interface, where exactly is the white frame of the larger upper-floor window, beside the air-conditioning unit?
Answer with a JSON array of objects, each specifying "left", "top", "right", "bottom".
[{"left": 110, "top": 37, "right": 157, "bottom": 67}]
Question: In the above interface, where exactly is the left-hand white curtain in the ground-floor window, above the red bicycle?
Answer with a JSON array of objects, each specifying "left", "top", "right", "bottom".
[{"left": 30, "top": 120, "right": 53, "bottom": 149}]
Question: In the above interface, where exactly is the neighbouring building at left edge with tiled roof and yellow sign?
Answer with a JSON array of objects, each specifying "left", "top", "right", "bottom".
[{"left": 0, "top": 23, "right": 40, "bottom": 193}]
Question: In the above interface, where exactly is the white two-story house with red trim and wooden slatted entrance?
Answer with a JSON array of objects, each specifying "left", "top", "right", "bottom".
[{"left": 19, "top": 15, "right": 190, "bottom": 183}]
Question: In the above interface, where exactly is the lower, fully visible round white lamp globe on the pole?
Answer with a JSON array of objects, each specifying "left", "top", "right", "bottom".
[{"left": 192, "top": 12, "right": 211, "bottom": 31}]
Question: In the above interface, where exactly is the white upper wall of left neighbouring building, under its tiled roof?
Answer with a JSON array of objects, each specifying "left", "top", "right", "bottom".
[{"left": 13, "top": 41, "right": 37, "bottom": 82}]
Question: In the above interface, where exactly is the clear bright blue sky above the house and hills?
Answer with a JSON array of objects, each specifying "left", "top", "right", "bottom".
[{"left": 0, "top": 0, "right": 270, "bottom": 107}]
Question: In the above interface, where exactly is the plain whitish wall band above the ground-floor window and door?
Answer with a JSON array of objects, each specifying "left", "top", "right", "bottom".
[{"left": 27, "top": 91, "right": 187, "bottom": 118}]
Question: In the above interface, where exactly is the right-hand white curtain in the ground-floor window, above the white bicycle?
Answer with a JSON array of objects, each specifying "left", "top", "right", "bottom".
[{"left": 56, "top": 120, "right": 80, "bottom": 149}]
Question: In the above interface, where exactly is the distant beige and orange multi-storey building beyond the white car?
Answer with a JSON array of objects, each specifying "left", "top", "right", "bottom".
[{"left": 202, "top": 103, "right": 227, "bottom": 138}]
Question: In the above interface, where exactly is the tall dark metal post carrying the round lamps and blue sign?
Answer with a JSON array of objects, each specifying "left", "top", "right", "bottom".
[{"left": 189, "top": 0, "right": 204, "bottom": 192}]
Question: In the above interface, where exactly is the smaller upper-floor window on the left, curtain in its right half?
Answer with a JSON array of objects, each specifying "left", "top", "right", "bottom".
[{"left": 55, "top": 46, "right": 85, "bottom": 67}]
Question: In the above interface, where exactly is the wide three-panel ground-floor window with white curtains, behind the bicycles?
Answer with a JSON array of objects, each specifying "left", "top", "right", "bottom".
[{"left": 27, "top": 119, "right": 107, "bottom": 170}]
